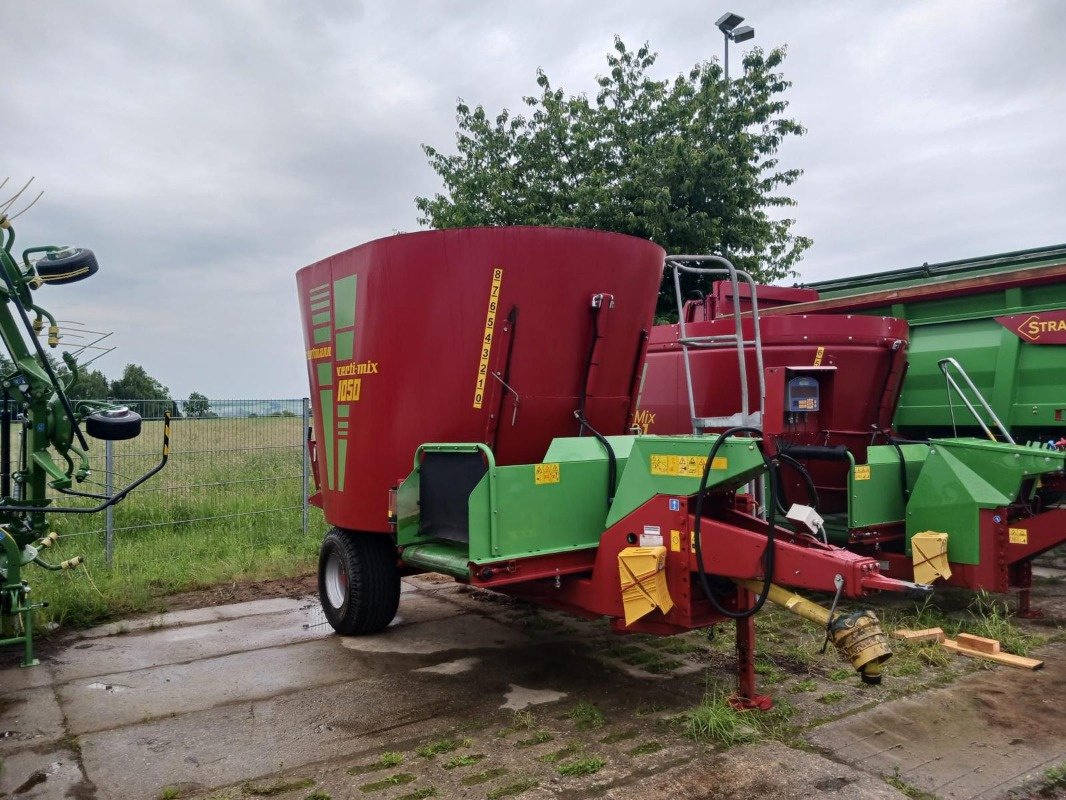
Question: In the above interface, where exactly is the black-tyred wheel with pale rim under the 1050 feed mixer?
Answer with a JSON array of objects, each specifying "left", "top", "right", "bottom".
[{"left": 319, "top": 528, "right": 400, "bottom": 636}]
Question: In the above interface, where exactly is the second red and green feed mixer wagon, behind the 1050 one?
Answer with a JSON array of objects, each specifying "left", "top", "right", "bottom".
[{"left": 636, "top": 258, "right": 1066, "bottom": 613}]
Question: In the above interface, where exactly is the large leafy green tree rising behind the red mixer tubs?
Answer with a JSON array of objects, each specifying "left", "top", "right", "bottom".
[{"left": 415, "top": 37, "right": 811, "bottom": 311}]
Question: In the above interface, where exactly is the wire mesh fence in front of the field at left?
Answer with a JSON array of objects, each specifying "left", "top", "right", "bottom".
[{"left": 51, "top": 398, "right": 310, "bottom": 565}]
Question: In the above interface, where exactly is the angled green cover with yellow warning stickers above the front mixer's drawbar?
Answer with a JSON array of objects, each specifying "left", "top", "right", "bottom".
[{"left": 607, "top": 435, "right": 764, "bottom": 527}]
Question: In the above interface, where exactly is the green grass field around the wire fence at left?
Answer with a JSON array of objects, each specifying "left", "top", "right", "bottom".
[{"left": 25, "top": 416, "right": 324, "bottom": 626}]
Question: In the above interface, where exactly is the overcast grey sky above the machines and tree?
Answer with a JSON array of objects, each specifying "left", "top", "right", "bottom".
[{"left": 0, "top": 0, "right": 1066, "bottom": 398}]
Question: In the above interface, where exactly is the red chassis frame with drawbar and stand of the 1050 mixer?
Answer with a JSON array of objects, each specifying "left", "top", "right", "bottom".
[{"left": 470, "top": 495, "right": 916, "bottom": 708}]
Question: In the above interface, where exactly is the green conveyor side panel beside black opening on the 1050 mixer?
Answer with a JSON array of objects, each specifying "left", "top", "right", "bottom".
[{"left": 469, "top": 453, "right": 608, "bottom": 563}]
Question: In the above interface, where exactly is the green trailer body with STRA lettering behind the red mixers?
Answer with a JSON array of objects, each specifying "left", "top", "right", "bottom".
[{"left": 797, "top": 245, "right": 1066, "bottom": 442}]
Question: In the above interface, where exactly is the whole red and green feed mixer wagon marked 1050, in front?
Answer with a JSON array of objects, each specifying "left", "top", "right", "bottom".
[{"left": 297, "top": 227, "right": 924, "bottom": 705}]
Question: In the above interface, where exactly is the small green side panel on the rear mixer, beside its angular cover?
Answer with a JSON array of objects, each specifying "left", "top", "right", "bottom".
[{"left": 844, "top": 445, "right": 930, "bottom": 529}]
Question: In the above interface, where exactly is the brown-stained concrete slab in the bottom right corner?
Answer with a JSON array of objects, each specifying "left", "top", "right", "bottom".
[{"left": 807, "top": 643, "right": 1066, "bottom": 800}]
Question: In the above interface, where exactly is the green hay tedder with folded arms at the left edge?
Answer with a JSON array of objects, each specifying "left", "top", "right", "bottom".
[{"left": 0, "top": 185, "right": 169, "bottom": 667}]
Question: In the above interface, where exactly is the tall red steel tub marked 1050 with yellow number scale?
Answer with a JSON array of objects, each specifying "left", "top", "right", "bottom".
[{"left": 297, "top": 227, "right": 665, "bottom": 532}]
